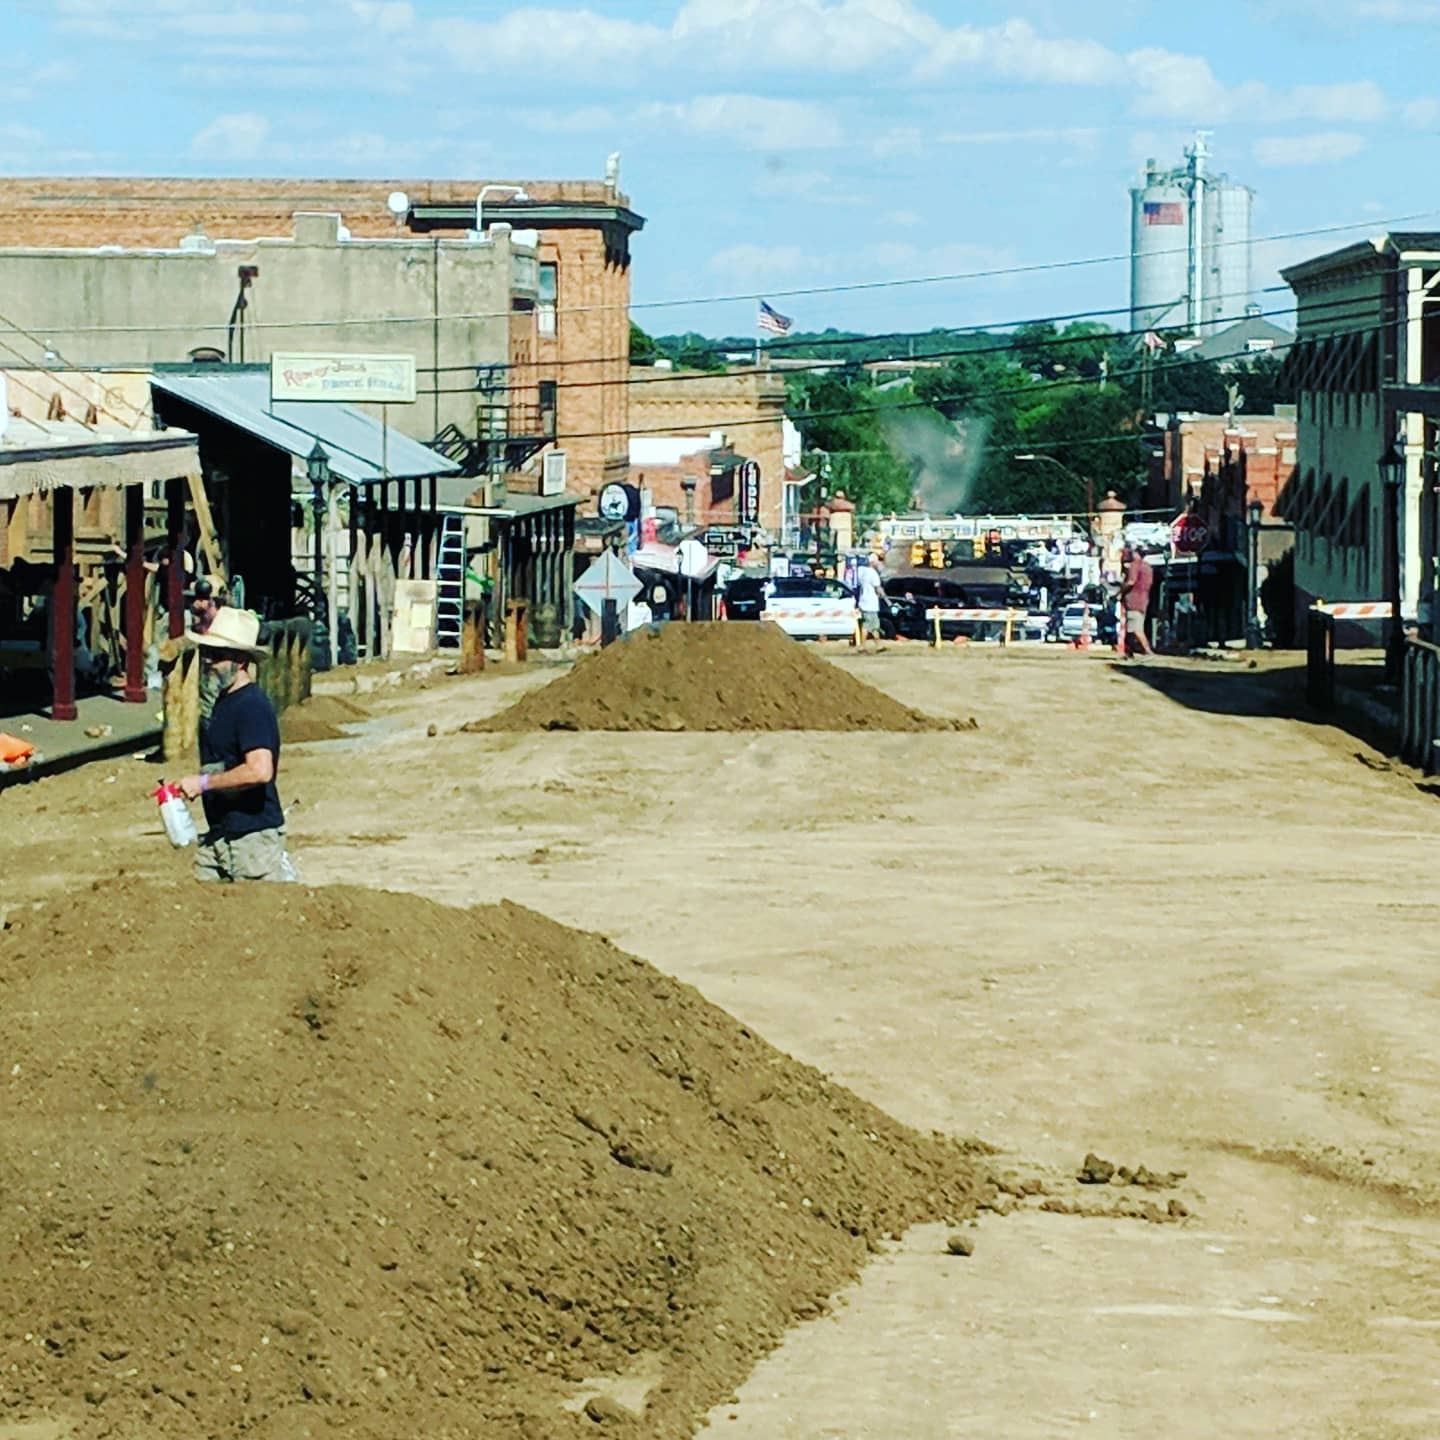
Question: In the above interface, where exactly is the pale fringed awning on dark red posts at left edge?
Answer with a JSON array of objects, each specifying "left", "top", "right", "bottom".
[{"left": 0, "top": 415, "right": 200, "bottom": 500}]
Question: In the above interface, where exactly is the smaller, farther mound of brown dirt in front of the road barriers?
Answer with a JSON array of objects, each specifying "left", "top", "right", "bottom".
[{"left": 464, "top": 624, "right": 952, "bottom": 732}]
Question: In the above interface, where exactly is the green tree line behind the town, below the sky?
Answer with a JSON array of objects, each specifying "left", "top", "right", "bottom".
[{"left": 631, "top": 321, "right": 1293, "bottom": 514}]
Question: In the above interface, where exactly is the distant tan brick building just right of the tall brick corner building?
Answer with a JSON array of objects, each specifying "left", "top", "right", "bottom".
[{"left": 629, "top": 366, "right": 785, "bottom": 533}]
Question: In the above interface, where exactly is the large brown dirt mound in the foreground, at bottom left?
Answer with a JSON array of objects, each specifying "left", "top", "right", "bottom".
[{"left": 0, "top": 880, "right": 982, "bottom": 1440}]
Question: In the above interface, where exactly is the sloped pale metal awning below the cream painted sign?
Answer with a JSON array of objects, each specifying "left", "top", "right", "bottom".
[{"left": 150, "top": 369, "right": 459, "bottom": 485}]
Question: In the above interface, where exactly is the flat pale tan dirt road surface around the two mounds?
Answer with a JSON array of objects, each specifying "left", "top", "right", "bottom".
[{"left": 0, "top": 649, "right": 1440, "bottom": 1440}]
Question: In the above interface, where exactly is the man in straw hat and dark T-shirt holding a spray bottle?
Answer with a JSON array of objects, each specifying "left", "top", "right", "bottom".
[{"left": 180, "top": 606, "right": 295, "bottom": 881}]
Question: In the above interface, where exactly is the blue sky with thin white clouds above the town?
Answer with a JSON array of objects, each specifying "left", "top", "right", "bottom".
[{"left": 0, "top": 0, "right": 1440, "bottom": 333}]
